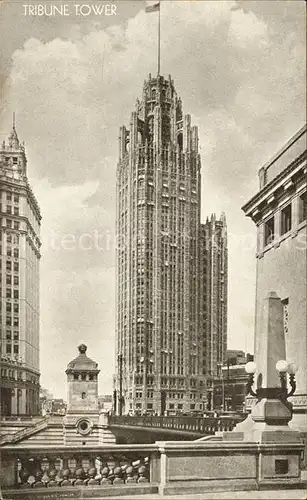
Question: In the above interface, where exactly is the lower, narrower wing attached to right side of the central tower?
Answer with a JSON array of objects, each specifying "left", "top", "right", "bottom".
[{"left": 200, "top": 213, "right": 228, "bottom": 378}]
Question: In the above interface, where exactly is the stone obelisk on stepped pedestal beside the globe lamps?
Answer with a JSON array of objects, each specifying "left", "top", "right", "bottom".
[{"left": 222, "top": 292, "right": 304, "bottom": 487}]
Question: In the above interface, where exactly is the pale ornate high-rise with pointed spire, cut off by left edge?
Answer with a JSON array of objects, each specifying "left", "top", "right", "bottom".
[{"left": 0, "top": 125, "right": 41, "bottom": 415}]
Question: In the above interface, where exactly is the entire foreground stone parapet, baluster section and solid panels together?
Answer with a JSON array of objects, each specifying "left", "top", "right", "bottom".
[{"left": 1, "top": 438, "right": 306, "bottom": 500}]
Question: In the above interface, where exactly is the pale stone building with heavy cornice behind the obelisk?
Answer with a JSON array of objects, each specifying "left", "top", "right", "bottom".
[{"left": 243, "top": 126, "right": 307, "bottom": 429}]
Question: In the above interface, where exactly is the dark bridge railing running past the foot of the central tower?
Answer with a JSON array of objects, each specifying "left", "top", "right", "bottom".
[{"left": 108, "top": 415, "right": 245, "bottom": 435}]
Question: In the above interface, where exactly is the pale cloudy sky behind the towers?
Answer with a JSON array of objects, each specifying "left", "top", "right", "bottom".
[{"left": 0, "top": 0, "right": 306, "bottom": 397}]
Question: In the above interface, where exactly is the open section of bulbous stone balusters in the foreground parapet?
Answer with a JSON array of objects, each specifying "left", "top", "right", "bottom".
[{"left": 1, "top": 445, "right": 161, "bottom": 489}]
